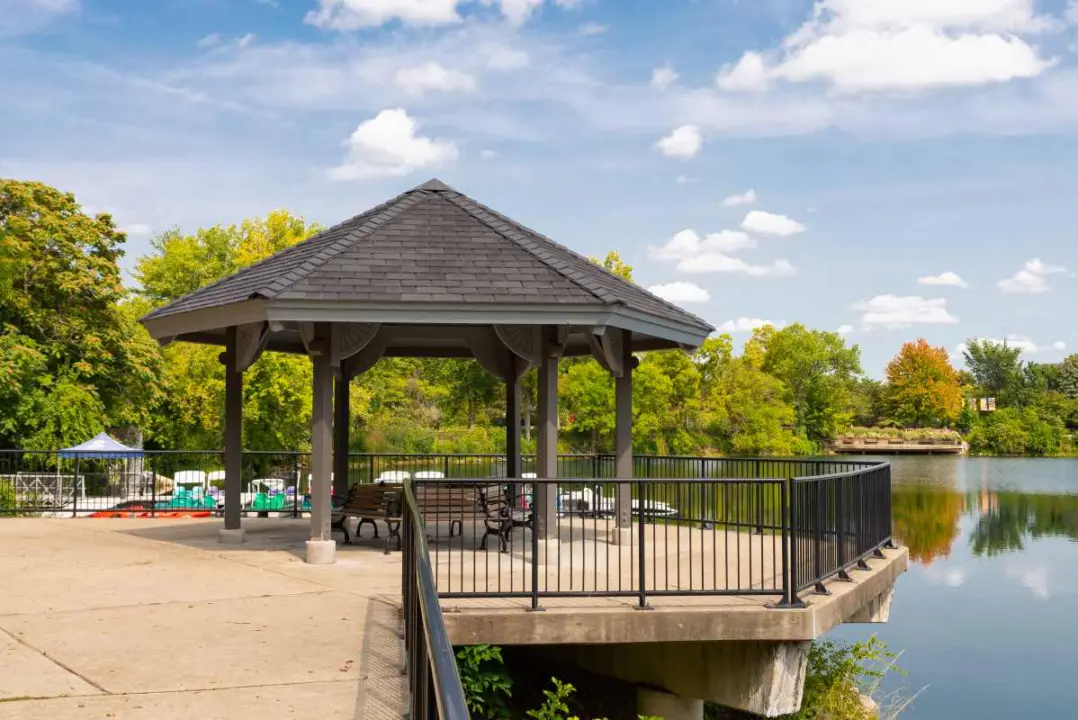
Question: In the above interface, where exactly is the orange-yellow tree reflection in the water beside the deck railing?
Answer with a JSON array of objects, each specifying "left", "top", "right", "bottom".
[{"left": 892, "top": 485, "right": 965, "bottom": 565}]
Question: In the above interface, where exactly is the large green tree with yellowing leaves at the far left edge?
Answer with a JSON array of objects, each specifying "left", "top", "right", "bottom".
[{"left": 0, "top": 180, "right": 158, "bottom": 448}]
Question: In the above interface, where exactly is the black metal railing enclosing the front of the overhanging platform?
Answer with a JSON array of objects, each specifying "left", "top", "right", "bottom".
[{"left": 410, "top": 458, "right": 890, "bottom": 609}]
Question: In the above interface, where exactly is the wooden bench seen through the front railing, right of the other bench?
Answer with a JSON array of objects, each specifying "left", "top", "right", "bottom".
[{"left": 415, "top": 482, "right": 513, "bottom": 553}]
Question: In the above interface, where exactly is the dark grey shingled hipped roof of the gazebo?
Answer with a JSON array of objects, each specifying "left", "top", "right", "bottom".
[{"left": 142, "top": 180, "right": 714, "bottom": 355}]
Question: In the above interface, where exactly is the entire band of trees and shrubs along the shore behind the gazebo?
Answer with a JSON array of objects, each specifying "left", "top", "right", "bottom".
[{"left": 6, "top": 179, "right": 1078, "bottom": 456}]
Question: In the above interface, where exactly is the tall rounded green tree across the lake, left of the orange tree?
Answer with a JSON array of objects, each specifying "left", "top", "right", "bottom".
[{"left": 745, "top": 323, "right": 861, "bottom": 442}]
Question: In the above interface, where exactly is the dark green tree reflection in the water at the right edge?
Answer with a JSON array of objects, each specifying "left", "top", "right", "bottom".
[{"left": 969, "top": 493, "right": 1078, "bottom": 557}]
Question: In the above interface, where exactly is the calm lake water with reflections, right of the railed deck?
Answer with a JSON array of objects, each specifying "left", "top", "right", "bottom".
[{"left": 830, "top": 457, "right": 1078, "bottom": 720}]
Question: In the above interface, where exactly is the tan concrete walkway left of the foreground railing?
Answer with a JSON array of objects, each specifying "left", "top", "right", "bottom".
[{"left": 0, "top": 518, "right": 404, "bottom": 720}]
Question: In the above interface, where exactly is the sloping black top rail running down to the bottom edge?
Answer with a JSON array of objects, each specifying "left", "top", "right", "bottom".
[{"left": 404, "top": 483, "right": 471, "bottom": 720}]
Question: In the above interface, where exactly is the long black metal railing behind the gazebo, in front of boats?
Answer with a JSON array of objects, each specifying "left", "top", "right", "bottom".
[{"left": 0, "top": 449, "right": 874, "bottom": 516}]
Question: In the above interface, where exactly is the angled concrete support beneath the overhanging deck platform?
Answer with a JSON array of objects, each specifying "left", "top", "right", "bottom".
[{"left": 558, "top": 641, "right": 812, "bottom": 720}]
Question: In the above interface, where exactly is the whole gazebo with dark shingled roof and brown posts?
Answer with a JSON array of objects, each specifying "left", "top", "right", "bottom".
[{"left": 141, "top": 180, "right": 714, "bottom": 564}]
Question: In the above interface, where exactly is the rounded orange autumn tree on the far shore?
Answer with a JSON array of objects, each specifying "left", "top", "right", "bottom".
[{"left": 886, "top": 338, "right": 962, "bottom": 428}]
